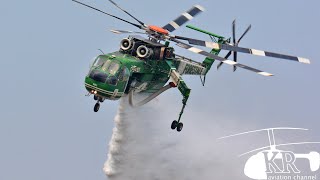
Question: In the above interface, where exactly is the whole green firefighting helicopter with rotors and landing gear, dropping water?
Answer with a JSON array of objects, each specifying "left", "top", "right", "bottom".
[{"left": 72, "top": 0, "right": 310, "bottom": 132}]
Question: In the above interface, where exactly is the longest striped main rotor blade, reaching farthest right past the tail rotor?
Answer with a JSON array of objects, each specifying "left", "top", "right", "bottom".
[{"left": 175, "top": 36, "right": 310, "bottom": 64}]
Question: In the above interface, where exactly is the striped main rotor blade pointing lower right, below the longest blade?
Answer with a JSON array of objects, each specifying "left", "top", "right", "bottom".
[{"left": 171, "top": 39, "right": 273, "bottom": 76}]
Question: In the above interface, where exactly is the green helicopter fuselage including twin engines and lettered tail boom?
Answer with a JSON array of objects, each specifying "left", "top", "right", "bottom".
[{"left": 85, "top": 36, "right": 212, "bottom": 101}]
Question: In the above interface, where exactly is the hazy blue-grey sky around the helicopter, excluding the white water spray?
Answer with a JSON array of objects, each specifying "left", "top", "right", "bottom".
[{"left": 0, "top": 0, "right": 320, "bottom": 180}]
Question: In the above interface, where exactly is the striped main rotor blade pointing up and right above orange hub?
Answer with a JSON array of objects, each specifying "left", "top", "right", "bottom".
[{"left": 163, "top": 5, "right": 204, "bottom": 32}]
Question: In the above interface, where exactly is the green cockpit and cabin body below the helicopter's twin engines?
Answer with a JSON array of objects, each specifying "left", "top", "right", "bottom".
[{"left": 85, "top": 39, "right": 170, "bottom": 100}]
